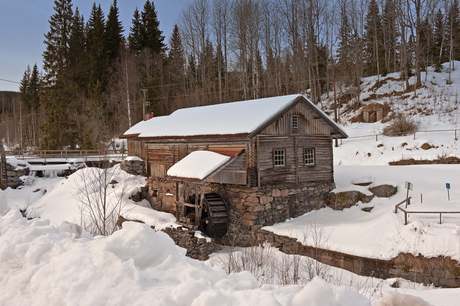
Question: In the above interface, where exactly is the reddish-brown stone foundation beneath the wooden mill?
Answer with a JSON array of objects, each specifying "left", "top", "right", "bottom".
[{"left": 147, "top": 177, "right": 335, "bottom": 246}]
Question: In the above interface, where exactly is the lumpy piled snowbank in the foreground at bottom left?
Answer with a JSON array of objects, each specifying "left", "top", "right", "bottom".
[{"left": 0, "top": 211, "right": 370, "bottom": 306}]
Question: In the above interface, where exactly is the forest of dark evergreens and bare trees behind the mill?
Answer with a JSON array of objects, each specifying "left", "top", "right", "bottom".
[{"left": 13, "top": 0, "right": 460, "bottom": 149}]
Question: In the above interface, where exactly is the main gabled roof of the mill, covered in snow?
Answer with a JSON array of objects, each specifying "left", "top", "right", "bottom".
[{"left": 121, "top": 95, "right": 347, "bottom": 138}]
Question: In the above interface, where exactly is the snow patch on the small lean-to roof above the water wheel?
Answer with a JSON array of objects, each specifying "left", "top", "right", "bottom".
[{"left": 167, "top": 150, "right": 230, "bottom": 180}]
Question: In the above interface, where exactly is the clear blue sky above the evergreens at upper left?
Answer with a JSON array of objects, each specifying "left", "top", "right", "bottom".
[{"left": 0, "top": 0, "right": 191, "bottom": 91}]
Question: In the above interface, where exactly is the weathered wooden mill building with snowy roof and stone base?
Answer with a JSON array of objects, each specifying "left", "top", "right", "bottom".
[{"left": 121, "top": 95, "right": 347, "bottom": 241}]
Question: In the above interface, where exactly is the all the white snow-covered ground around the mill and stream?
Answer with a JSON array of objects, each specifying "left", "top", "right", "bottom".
[{"left": 0, "top": 63, "right": 460, "bottom": 306}]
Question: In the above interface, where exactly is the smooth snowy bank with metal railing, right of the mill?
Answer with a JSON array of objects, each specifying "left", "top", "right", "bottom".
[{"left": 264, "top": 165, "right": 460, "bottom": 260}]
